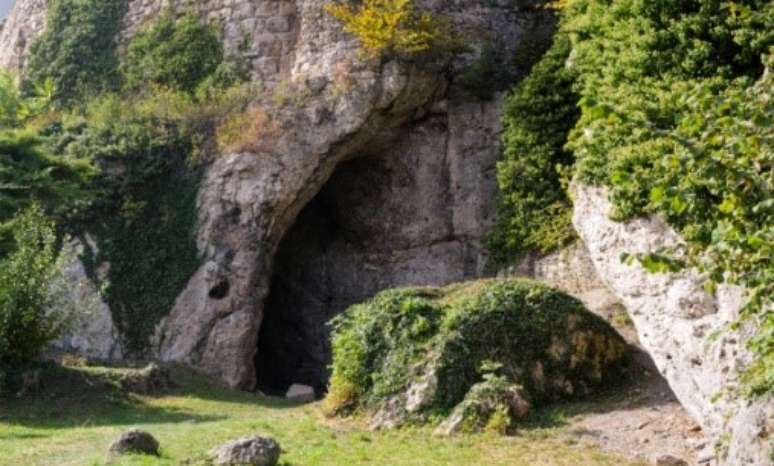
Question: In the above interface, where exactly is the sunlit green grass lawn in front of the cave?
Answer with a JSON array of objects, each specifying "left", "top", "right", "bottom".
[{"left": 0, "top": 367, "right": 648, "bottom": 466}]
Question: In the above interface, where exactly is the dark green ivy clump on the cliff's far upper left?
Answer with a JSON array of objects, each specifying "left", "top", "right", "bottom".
[{"left": 25, "top": 0, "right": 127, "bottom": 104}]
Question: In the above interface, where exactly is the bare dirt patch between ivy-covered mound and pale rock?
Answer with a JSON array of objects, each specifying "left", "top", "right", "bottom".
[{"left": 568, "top": 354, "right": 717, "bottom": 466}]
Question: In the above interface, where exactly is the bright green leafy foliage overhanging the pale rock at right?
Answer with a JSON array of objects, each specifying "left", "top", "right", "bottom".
[{"left": 566, "top": 0, "right": 774, "bottom": 394}]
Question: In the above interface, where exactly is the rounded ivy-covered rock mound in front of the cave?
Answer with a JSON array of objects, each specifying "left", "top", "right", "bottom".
[{"left": 325, "top": 279, "right": 626, "bottom": 432}]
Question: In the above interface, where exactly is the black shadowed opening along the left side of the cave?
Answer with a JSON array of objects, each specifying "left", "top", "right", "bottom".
[{"left": 255, "top": 194, "right": 337, "bottom": 396}]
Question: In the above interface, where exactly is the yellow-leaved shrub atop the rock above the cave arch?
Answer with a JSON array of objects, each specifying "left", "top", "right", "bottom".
[{"left": 325, "top": 0, "right": 455, "bottom": 58}]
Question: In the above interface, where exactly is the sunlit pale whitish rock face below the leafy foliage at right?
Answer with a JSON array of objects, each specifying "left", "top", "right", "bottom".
[{"left": 573, "top": 186, "right": 774, "bottom": 465}]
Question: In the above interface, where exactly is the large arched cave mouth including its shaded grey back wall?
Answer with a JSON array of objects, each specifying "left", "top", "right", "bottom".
[{"left": 255, "top": 115, "right": 499, "bottom": 396}]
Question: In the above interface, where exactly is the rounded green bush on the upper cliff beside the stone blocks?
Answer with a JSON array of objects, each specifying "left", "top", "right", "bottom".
[{"left": 122, "top": 12, "right": 224, "bottom": 93}]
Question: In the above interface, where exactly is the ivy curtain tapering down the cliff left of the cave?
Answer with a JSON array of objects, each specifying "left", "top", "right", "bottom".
[{"left": 56, "top": 92, "right": 205, "bottom": 352}]
